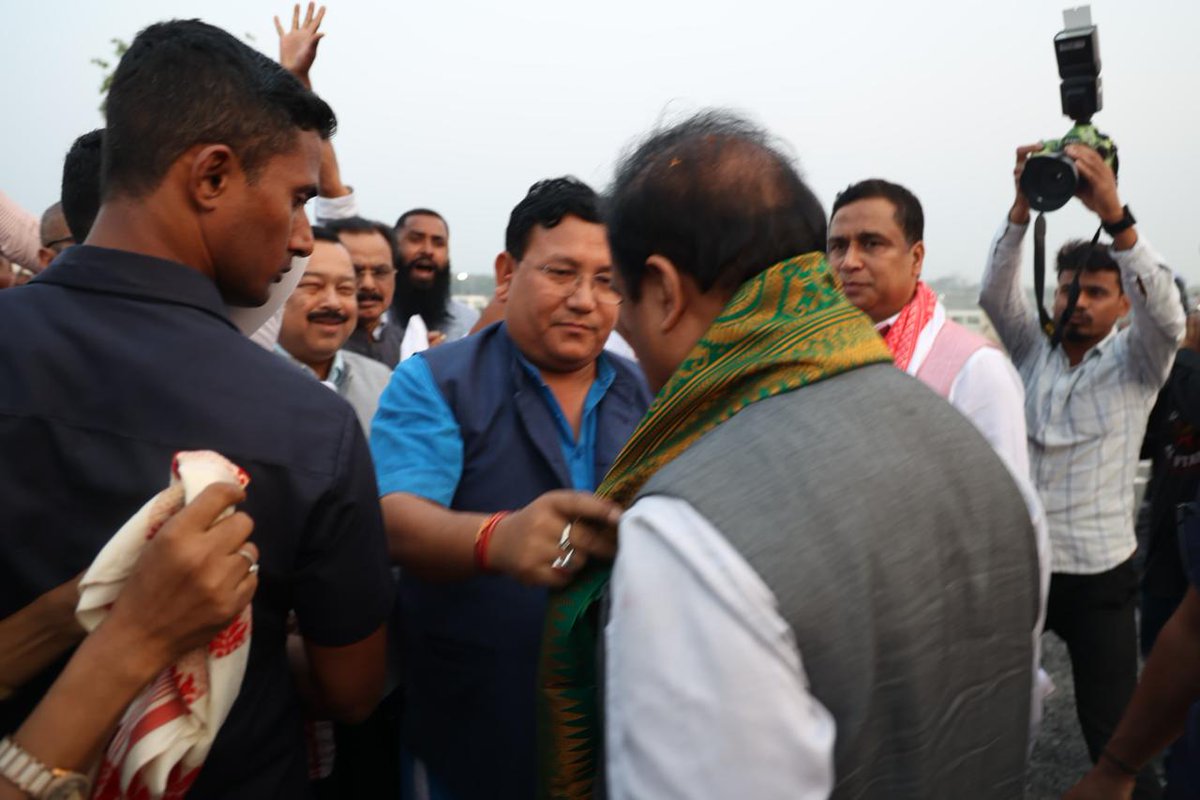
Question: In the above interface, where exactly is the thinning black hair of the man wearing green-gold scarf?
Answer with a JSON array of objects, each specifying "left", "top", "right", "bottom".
[{"left": 606, "top": 110, "right": 826, "bottom": 300}]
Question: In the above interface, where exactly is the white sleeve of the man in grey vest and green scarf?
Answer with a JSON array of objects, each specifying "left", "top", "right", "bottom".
[{"left": 605, "top": 497, "right": 835, "bottom": 800}]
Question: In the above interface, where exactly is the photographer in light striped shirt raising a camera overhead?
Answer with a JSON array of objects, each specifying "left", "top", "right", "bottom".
[{"left": 979, "top": 144, "right": 1184, "bottom": 798}]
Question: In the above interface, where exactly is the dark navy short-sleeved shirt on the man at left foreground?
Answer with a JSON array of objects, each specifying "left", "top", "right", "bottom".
[{"left": 0, "top": 245, "right": 395, "bottom": 800}]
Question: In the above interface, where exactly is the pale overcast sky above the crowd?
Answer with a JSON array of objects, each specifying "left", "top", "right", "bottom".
[{"left": 0, "top": 0, "right": 1200, "bottom": 283}]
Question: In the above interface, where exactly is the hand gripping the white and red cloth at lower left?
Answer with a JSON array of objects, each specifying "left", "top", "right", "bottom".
[{"left": 102, "top": 483, "right": 258, "bottom": 674}]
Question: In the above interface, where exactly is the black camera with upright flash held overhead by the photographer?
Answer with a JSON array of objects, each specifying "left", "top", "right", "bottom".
[{"left": 1021, "top": 6, "right": 1118, "bottom": 211}]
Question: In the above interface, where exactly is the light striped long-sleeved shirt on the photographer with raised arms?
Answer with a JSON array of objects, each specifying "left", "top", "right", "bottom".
[{"left": 979, "top": 222, "right": 1184, "bottom": 575}]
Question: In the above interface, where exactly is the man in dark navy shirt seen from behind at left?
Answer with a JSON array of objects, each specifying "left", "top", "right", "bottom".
[{"left": 0, "top": 20, "right": 394, "bottom": 799}]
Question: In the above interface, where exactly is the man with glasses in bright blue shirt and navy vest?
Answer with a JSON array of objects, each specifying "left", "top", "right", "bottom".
[{"left": 371, "top": 178, "right": 649, "bottom": 799}]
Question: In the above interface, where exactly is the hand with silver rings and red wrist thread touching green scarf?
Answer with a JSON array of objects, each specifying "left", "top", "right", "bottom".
[{"left": 488, "top": 489, "right": 620, "bottom": 587}]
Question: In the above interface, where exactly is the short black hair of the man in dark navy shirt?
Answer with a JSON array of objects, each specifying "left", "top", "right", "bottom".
[{"left": 101, "top": 19, "right": 337, "bottom": 198}]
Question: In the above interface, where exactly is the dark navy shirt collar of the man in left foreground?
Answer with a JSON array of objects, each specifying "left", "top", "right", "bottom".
[{"left": 30, "top": 245, "right": 236, "bottom": 330}]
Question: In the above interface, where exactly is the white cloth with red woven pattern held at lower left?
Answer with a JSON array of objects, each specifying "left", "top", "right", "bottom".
[{"left": 76, "top": 451, "right": 251, "bottom": 800}]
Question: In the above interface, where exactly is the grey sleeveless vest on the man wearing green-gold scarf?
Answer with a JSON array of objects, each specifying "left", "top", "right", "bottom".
[{"left": 642, "top": 365, "right": 1038, "bottom": 800}]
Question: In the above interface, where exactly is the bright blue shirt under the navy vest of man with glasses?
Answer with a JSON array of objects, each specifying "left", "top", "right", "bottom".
[{"left": 371, "top": 354, "right": 616, "bottom": 506}]
